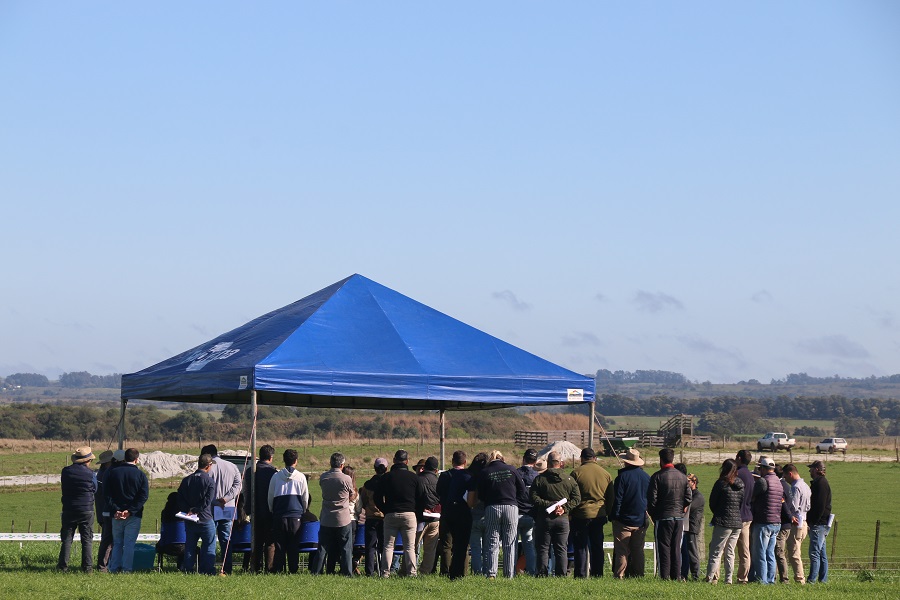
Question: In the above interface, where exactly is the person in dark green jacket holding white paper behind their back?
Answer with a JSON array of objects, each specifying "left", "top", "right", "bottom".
[{"left": 530, "top": 452, "right": 581, "bottom": 577}]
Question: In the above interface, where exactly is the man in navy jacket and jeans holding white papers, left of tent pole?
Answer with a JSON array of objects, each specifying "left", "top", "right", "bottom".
[{"left": 175, "top": 454, "right": 216, "bottom": 575}]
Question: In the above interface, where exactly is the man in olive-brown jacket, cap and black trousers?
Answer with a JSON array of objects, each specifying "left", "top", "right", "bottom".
[{"left": 569, "top": 448, "right": 613, "bottom": 578}]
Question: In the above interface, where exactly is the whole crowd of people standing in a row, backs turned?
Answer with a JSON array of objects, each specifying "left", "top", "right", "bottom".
[{"left": 57, "top": 445, "right": 831, "bottom": 584}]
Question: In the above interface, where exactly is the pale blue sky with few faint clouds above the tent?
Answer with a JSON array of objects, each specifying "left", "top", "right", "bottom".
[{"left": 0, "top": 0, "right": 900, "bottom": 382}]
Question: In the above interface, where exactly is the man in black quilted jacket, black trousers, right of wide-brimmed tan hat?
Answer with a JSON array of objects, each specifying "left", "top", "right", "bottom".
[{"left": 647, "top": 448, "right": 693, "bottom": 580}]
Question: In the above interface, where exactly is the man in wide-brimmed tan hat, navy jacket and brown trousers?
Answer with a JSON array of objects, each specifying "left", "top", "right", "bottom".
[{"left": 609, "top": 448, "right": 650, "bottom": 579}]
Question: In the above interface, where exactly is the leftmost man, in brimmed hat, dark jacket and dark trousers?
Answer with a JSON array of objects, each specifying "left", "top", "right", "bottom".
[{"left": 56, "top": 446, "right": 97, "bottom": 573}]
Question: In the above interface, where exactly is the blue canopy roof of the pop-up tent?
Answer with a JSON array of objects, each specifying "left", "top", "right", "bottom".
[{"left": 122, "top": 275, "right": 594, "bottom": 410}]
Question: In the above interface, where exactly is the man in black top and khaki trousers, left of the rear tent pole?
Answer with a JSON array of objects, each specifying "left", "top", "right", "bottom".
[{"left": 375, "top": 449, "right": 419, "bottom": 577}]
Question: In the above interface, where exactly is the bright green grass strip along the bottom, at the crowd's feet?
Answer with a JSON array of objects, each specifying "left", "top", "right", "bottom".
[{"left": 0, "top": 571, "right": 897, "bottom": 600}]
